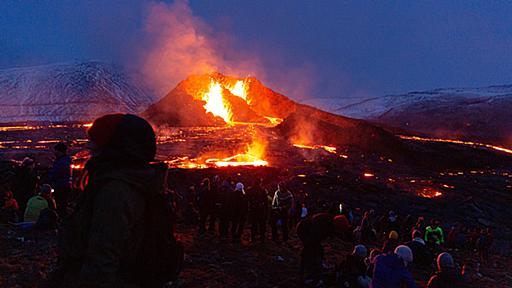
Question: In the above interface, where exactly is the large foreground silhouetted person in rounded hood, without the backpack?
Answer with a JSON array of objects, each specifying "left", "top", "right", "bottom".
[{"left": 48, "top": 114, "right": 164, "bottom": 287}]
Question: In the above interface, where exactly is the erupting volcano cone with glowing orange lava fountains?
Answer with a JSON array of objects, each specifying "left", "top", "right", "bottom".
[{"left": 144, "top": 73, "right": 399, "bottom": 151}]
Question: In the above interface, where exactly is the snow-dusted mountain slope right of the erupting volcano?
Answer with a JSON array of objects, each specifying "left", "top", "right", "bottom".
[{"left": 308, "top": 85, "right": 512, "bottom": 147}]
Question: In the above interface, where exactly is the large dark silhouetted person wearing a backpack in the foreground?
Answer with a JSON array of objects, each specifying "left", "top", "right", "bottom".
[{"left": 51, "top": 114, "right": 183, "bottom": 287}]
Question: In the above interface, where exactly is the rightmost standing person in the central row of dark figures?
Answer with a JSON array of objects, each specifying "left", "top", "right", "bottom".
[{"left": 270, "top": 183, "right": 293, "bottom": 242}]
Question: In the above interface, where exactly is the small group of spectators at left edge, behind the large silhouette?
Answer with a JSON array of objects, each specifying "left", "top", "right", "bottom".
[{"left": 0, "top": 143, "right": 72, "bottom": 229}]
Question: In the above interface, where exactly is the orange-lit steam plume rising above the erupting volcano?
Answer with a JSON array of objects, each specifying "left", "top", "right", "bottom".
[{"left": 138, "top": 0, "right": 316, "bottom": 98}]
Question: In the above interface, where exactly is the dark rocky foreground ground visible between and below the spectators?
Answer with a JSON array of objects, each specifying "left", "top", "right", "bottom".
[{"left": 0, "top": 225, "right": 512, "bottom": 288}]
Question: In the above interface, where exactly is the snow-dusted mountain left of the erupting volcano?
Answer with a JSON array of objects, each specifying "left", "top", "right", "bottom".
[{"left": 0, "top": 62, "right": 155, "bottom": 123}]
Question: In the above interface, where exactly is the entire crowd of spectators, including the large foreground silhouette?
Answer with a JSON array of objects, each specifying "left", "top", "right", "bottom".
[{"left": 0, "top": 114, "right": 493, "bottom": 288}]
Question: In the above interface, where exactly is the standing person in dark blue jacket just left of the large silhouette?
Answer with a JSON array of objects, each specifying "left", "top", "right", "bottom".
[{"left": 47, "top": 142, "right": 72, "bottom": 215}]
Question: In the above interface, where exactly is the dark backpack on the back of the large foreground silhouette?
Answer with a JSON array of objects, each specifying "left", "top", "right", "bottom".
[{"left": 133, "top": 163, "right": 184, "bottom": 287}]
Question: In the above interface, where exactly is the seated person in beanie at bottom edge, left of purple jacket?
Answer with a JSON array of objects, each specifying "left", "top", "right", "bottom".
[{"left": 337, "top": 245, "right": 371, "bottom": 288}]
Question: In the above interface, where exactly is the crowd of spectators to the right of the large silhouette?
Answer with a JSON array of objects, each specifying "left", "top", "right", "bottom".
[{"left": 182, "top": 170, "right": 493, "bottom": 288}]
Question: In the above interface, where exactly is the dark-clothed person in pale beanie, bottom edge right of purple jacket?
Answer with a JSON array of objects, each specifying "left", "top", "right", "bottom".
[{"left": 427, "top": 252, "right": 463, "bottom": 288}]
